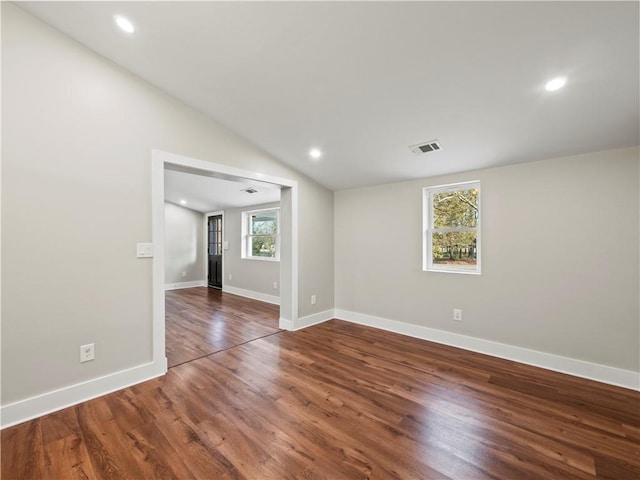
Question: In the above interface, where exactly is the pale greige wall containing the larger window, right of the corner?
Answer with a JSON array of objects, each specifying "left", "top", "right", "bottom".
[{"left": 335, "top": 147, "right": 640, "bottom": 371}]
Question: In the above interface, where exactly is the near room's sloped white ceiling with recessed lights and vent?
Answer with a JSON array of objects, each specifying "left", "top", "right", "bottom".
[{"left": 18, "top": 1, "right": 640, "bottom": 190}]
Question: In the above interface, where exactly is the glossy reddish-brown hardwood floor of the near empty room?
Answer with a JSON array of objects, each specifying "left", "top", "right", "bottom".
[{"left": 2, "top": 314, "right": 640, "bottom": 480}]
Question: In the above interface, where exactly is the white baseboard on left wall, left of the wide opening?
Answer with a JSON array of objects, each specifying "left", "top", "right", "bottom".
[{"left": 0, "top": 358, "right": 167, "bottom": 428}]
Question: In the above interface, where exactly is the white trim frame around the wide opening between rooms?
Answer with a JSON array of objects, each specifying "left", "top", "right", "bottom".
[{"left": 151, "top": 150, "right": 298, "bottom": 372}]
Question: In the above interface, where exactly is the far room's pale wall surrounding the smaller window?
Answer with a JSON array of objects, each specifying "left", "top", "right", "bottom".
[{"left": 224, "top": 203, "right": 280, "bottom": 297}]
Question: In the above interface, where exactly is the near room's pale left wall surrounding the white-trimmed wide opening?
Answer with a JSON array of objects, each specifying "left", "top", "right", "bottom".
[{"left": 2, "top": 2, "right": 334, "bottom": 406}]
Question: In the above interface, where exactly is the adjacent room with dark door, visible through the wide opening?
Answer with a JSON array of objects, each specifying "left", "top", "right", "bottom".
[{"left": 164, "top": 170, "right": 280, "bottom": 368}]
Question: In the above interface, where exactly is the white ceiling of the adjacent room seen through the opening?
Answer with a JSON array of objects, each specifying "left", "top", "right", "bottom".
[{"left": 164, "top": 170, "right": 280, "bottom": 213}]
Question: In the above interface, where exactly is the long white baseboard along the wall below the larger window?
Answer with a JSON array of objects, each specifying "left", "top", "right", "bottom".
[{"left": 335, "top": 308, "right": 640, "bottom": 390}]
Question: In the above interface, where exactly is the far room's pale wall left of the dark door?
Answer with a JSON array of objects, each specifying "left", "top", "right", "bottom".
[{"left": 164, "top": 202, "right": 205, "bottom": 285}]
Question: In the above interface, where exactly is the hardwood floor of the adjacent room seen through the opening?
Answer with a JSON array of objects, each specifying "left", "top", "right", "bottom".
[{"left": 165, "top": 287, "right": 280, "bottom": 367}]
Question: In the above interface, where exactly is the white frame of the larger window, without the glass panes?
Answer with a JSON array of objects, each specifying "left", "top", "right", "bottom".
[{"left": 422, "top": 180, "right": 482, "bottom": 275}]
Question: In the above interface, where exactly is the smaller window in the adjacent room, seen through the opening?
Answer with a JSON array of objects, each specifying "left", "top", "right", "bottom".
[{"left": 242, "top": 208, "right": 280, "bottom": 261}]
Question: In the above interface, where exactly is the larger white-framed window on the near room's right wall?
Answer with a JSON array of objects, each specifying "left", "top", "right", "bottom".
[{"left": 423, "top": 182, "right": 480, "bottom": 273}]
